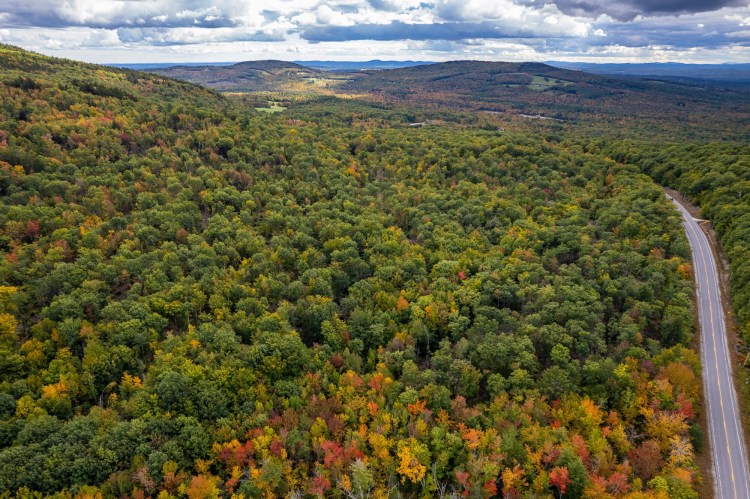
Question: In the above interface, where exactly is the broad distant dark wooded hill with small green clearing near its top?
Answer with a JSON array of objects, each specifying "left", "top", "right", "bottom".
[{"left": 341, "top": 61, "right": 750, "bottom": 136}]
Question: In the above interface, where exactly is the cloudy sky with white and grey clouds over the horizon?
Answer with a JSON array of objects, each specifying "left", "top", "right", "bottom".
[{"left": 0, "top": 0, "right": 750, "bottom": 64}]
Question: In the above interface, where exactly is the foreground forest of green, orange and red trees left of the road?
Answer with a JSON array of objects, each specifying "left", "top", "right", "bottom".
[{"left": 0, "top": 46, "right": 702, "bottom": 498}]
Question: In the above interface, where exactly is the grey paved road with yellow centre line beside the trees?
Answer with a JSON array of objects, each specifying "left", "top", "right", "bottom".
[{"left": 670, "top": 198, "right": 750, "bottom": 499}]
